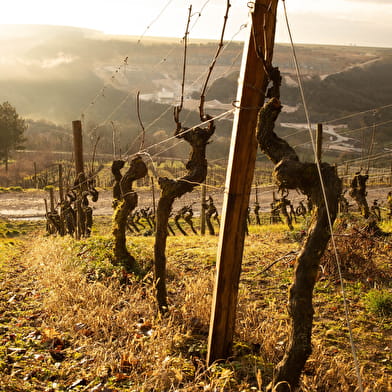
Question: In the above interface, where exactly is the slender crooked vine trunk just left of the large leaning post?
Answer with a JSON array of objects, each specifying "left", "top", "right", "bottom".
[{"left": 154, "top": 121, "right": 215, "bottom": 313}]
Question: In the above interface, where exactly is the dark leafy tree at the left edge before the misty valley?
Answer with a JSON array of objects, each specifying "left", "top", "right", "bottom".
[{"left": 0, "top": 102, "right": 27, "bottom": 171}]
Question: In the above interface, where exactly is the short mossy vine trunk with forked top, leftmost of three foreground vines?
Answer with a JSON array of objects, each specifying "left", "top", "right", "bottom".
[{"left": 112, "top": 156, "right": 147, "bottom": 272}]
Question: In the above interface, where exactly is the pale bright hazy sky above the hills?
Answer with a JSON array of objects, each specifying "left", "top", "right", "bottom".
[{"left": 0, "top": 0, "right": 392, "bottom": 47}]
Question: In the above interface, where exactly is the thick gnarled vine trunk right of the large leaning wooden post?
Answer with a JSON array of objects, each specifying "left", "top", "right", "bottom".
[{"left": 257, "top": 98, "right": 342, "bottom": 392}]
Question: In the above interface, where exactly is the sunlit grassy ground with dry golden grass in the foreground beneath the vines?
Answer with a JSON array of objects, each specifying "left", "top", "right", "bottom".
[{"left": 0, "top": 217, "right": 392, "bottom": 392}]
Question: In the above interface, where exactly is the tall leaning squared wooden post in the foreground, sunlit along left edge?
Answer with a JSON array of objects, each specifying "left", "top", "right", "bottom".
[{"left": 207, "top": 0, "right": 278, "bottom": 365}]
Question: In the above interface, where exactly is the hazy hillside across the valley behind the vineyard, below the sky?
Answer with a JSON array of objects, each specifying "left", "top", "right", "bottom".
[{"left": 0, "top": 25, "right": 392, "bottom": 161}]
